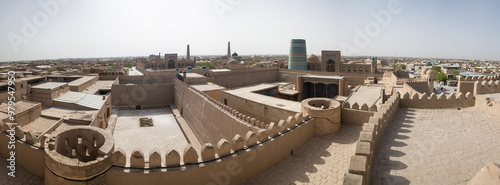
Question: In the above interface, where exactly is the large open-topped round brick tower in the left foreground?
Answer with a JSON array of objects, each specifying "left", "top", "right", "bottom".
[{"left": 45, "top": 126, "right": 114, "bottom": 185}]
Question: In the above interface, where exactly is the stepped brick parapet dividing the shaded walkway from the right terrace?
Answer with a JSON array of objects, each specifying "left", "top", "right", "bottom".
[{"left": 344, "top": 93, "right": 401, "bottom": 184}]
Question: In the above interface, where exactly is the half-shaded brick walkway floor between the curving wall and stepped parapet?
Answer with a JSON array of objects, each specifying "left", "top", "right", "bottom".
[{"left": 243, "top": 125, "right": 361, "bottom": 185}]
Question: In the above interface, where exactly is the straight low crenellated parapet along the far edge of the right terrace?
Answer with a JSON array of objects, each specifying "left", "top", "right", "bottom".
[{"left": 401, "top": 92, "right": 475, "bottom": 109}]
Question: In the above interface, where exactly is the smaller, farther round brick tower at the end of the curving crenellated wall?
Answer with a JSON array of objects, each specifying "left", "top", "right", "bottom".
[{"left": 301, "top": 98, "right": 341, "bottom": 135}]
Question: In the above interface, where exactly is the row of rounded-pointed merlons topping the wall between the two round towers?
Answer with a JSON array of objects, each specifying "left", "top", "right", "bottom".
[{"left": 111, "top": 113, "right": 309, "bottom": 169}]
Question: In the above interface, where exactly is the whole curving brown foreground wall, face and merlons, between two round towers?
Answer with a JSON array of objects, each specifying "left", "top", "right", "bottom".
[{"left": 106, "top": 110, "right": 314, "bottom": 185}]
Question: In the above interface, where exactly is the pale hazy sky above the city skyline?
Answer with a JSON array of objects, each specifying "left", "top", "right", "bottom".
[{"left": 0, "top": 0, "right": 500, "bottom": 61}]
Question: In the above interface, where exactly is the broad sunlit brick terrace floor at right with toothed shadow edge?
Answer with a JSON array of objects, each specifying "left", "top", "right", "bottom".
[{"left": 371, "top": 108, "right": 500, "bottom": 184}]
